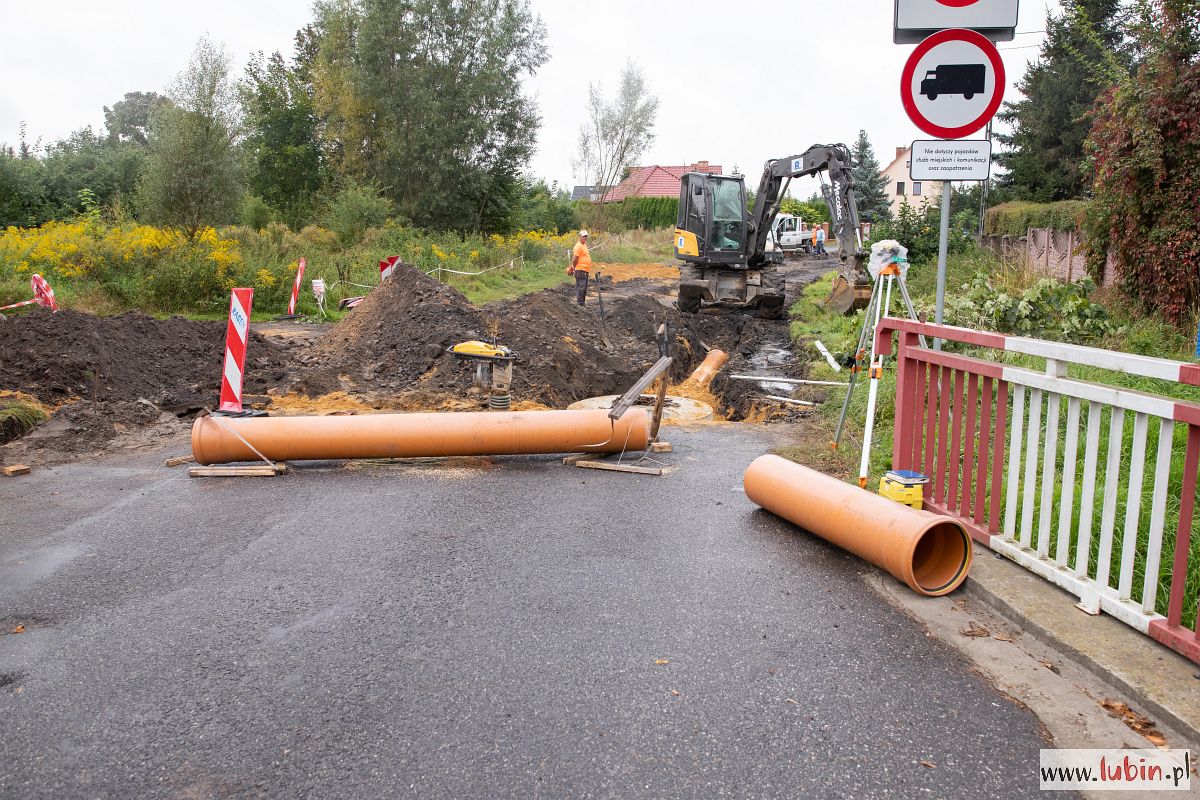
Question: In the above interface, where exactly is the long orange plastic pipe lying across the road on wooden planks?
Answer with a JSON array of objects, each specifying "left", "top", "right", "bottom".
[{"left": 192, "top": 408, "right": 649, "bottom": 464}]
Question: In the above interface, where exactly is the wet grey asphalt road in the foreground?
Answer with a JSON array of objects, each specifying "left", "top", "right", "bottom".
[{"left": 0, "top": 426, "right": 1043, "bottom": 799}]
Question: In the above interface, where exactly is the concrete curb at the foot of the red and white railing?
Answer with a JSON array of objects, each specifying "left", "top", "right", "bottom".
[{"left": 962, "top": 543, "right": 1200, "bottom": 748}]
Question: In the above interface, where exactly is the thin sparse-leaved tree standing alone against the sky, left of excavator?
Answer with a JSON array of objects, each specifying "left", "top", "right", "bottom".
[{"left": 575, "top": 61, "right": 659, "bottom": 219}]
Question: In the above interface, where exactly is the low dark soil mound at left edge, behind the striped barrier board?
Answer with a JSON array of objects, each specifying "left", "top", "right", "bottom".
[{"left": 0, "top": 308, "right": 288, "bottom": 422}]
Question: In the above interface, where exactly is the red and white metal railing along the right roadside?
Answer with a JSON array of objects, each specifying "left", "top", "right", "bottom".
[{"left": 876, "top": 318, "right": 1200, "bottom": 662}]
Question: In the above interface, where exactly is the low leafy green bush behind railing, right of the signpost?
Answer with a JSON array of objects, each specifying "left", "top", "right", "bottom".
[{"left": 946, "top": 272, "right": 1118, "bottom": 343}]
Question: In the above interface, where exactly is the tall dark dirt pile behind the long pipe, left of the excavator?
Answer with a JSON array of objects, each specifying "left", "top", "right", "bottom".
[{"left": 290, "top": 261, "right": 811, "bottom": 419}]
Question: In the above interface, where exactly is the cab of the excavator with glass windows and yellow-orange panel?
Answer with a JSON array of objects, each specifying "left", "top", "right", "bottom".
[{"left": 674, "top": 173, "right": 746, "bottom": 266}]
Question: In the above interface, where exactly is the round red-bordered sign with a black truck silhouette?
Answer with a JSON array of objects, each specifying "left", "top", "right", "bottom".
[{"left": 900, "top": 29, "right": 1004, "bottom": 139}]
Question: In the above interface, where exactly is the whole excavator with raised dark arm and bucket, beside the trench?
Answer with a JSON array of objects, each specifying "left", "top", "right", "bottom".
[{"left": 674, "top": 144, "right": 871, "bottom": 319}]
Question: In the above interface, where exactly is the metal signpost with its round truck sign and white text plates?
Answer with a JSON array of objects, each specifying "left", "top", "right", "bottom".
[{"left": 896, "top": 20, "right": 1016, "bottom": 349}]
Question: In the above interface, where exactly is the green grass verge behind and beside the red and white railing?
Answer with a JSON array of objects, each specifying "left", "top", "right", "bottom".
[{"left": 781, "top": 247, "right": 1200, "bottom": 626}]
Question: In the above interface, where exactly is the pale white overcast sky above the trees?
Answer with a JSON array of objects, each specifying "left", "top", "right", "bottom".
[{"left": 0, "top": 0, "right": 1057, "bottom": 194}]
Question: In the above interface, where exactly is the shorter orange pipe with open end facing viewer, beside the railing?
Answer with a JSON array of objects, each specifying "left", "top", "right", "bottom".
[{"left": 742, "top": 456, "right": 971, "bottom": 597}]
